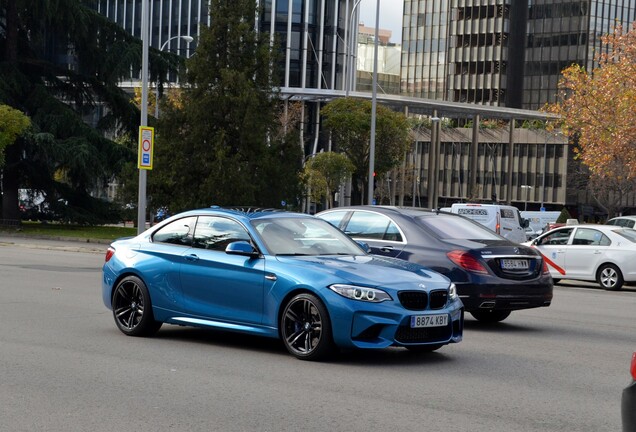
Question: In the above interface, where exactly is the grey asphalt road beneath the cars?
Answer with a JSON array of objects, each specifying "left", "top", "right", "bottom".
[{"left": 0, "top": 238, "right": 636, "bottom": 432}]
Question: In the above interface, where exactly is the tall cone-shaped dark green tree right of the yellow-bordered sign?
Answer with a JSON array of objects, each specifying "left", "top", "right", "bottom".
[{"left": 149, "top": 0, "right": 302, "bottom": 211}]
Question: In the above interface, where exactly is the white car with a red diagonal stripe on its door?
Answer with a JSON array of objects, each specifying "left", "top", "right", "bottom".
[{"left": 524, "top": 224, "right": 636, "bottom": 290}]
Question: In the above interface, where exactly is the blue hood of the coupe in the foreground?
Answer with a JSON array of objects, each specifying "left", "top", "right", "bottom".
[{"left": 276, "top": 255, "right": 450, "bottom": 289}]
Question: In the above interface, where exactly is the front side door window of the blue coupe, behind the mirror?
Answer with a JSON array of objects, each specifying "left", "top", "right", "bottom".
[{"left": 192, "top": 216, "right": 251, "bottom": 251}]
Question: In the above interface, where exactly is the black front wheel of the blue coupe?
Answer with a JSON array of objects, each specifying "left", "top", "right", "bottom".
[{"left": 280, "top": 293, "right": 334, "bottom": 360}]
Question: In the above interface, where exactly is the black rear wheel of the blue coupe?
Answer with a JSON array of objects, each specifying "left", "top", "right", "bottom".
[{"left": 112, "top": 276, "right": 162, "bottom": 336}]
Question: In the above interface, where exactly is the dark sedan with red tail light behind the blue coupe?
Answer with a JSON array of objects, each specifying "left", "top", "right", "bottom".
[{"left": 317, "top": 206, "right": 553, "bottom": 322}]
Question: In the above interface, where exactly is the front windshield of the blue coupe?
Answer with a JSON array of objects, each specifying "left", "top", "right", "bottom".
[{"left": 252, "top": 217, "right": 365, "bottom": 255}]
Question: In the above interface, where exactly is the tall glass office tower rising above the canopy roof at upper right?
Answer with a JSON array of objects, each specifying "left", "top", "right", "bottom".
[{"left": 401, "top": 0, "right": 636, "bottom": 110}]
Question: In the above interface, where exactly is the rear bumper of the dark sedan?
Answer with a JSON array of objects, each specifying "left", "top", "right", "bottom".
[{"left": 456, "top": 280, "right": 553, "bottom": 312}]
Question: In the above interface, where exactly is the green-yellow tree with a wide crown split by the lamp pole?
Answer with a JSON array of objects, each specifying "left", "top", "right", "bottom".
[{"left": 321, "top": 98, "right": 410, "bottom": 204}]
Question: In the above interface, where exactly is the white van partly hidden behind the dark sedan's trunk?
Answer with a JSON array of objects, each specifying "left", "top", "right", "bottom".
[{"left": 442, "top": 203, "right": 528, "bottom": 243}]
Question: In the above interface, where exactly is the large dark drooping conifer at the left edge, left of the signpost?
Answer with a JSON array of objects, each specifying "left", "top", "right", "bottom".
[{"left": 0, "top": 0, "right": 179, "bottom": 221}]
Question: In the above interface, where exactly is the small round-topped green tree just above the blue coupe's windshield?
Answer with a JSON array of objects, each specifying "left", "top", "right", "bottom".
[{"left": 303, "top": 152, "right": 355, "bottom": 208}]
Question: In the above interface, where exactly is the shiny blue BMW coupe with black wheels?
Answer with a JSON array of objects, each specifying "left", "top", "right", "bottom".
[{"left": 102, "top": 207, "right": 464, "bottom": 360}]
